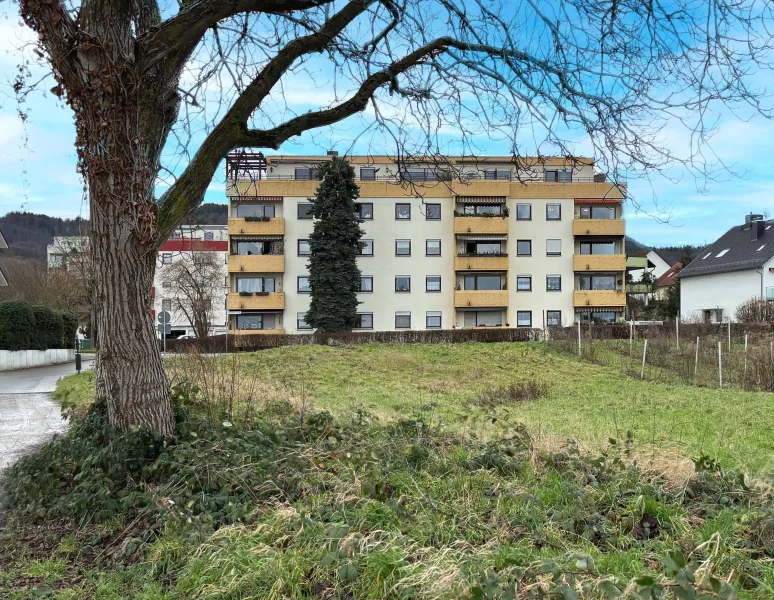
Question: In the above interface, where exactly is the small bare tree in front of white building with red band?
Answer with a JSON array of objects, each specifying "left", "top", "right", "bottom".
[{"left": 161, "top": 240, "right": 226, "bottom": 338}]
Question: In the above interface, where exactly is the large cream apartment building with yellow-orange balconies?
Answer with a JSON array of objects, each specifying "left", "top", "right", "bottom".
[{"left": 226, "top": 152, "right": 626, "bottom": 333}]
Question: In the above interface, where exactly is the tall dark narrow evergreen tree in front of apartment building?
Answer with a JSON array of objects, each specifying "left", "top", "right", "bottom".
[{"left": 306, "top": 157, "right": 364, "bottom": 333}]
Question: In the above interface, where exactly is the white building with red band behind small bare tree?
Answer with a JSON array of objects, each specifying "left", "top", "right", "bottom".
[{"left": 151, "top": 225, "right": 228, "bottom": 338}]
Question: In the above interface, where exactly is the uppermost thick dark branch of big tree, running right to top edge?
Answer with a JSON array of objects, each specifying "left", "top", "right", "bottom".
[{"left": 139, "top": 0, "right": 333, "bottom": 69}]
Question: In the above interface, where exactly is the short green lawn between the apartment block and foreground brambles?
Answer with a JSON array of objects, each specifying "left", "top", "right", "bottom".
[{"left": 235, "top": 343, "right": 774, "bottom": 473}]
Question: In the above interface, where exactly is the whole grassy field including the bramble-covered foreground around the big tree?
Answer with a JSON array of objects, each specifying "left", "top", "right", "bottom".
[{"left": 0, "top": 344, "right": 774, "bottom": 600}]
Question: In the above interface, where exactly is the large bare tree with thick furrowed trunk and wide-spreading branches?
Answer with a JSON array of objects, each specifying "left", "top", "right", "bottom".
[{"left": 16, "top": 0, "right": 772, "bottom": 435}]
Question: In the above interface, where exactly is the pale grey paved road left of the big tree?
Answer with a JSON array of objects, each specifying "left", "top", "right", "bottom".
[{"left": 0, "top": 358, "right": 92, "bottom": 471}]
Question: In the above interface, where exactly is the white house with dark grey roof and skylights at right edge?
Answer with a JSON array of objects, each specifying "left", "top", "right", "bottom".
[{"left": 676, "top": 215, "right": 774, "bottom": 323}]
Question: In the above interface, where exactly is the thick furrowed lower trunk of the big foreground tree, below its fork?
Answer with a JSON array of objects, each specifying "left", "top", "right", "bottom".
[{"left": 91, "top": 200, "right": 174, "bottom": 436}]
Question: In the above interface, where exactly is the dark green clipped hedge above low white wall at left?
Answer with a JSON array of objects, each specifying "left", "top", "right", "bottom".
[{"left": 0, "top": 301, "right": 78, "bottom": 350}]
